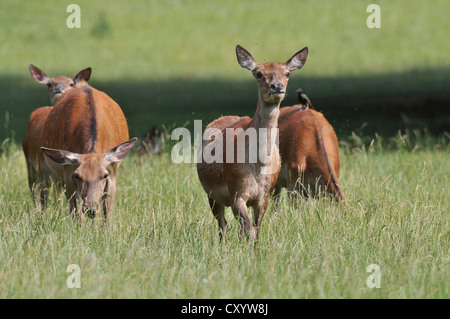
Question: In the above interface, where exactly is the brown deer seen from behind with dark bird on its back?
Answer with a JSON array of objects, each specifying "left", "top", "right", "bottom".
[{"left": 274, "top": 89, "right": 344, "bottom": 201}]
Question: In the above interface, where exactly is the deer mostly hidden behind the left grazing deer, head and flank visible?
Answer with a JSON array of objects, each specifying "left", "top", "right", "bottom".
[{"left": 22, "top": 64, "right": 92, "bottom": 199}]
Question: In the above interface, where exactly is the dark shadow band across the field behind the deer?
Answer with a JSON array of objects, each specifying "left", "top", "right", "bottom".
[{"left": 0, "top": 67, "right": 450, "bottom": 143}]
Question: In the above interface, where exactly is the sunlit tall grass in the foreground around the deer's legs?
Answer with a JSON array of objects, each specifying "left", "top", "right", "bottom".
[{"left": 0, "top": 131, "right": 450, "bottom": 298}]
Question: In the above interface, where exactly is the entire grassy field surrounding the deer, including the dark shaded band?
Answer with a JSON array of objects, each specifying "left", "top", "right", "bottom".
[{"left": 0, "top": 0, "right": 450, "bottom": 298}]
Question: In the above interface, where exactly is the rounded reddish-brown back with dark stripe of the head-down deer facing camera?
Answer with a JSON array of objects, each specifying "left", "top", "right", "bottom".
[{"left": 42, "top": 87, "right": 129, "bottom": 158}]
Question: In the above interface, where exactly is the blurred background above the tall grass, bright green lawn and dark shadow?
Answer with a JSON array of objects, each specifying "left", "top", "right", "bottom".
[{"left": 0, "top": 0, "right": 450, "bottom": 142}]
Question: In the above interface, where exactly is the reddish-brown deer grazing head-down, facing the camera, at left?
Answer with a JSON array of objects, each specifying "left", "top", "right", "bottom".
[{"left": 24, "top": 85, "right": 137, "bottom": 218}]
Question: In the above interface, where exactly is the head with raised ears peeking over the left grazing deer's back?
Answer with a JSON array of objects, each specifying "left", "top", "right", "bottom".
[{"left": 30, "top": 64, "right": 92, "bottom": 104}]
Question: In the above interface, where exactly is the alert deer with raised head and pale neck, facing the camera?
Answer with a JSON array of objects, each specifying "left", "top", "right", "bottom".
[{"left": 197, "top": 45, "right": 308, "bottom": 241}]
